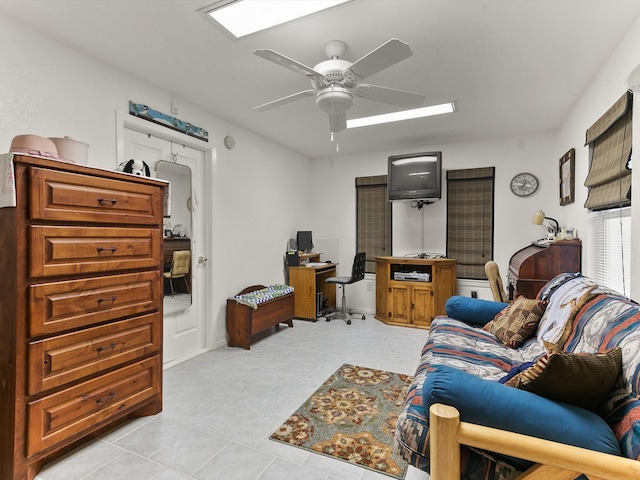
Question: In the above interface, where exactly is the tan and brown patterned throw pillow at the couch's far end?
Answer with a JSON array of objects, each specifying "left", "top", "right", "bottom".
[{"left": 484, "top": 296, "right": 547, "bottom": 348}]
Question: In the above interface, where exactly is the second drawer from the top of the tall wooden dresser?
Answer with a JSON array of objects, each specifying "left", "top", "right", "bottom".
[{"left": 29, "top": 225, "right": 162, "bottom": 277}]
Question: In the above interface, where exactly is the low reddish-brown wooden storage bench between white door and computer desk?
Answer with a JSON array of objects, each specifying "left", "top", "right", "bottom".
[{"left": 227, "top": 285, "right": 295, "bottom": 350}]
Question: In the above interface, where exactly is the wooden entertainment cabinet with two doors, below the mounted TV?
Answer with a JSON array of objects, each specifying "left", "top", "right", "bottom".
[{"left": 375, "top": 257, "right": 457, "bottom": 328}]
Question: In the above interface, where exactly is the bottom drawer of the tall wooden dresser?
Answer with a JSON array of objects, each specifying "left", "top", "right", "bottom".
[{"left": 26, "top": 356, "right": 162, "bottom": 457}]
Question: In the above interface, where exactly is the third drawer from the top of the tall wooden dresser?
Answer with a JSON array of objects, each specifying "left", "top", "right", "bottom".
[{"left": 29, "top": 270, "right": 163, "bottom": 337}]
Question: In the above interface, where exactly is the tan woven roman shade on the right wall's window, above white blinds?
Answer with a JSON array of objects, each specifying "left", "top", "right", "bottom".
[{"left": 584, "top": 92, "right": 633, "bottom": 210}]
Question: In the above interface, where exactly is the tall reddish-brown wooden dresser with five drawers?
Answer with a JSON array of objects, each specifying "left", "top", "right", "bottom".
[{"left": 0, "top": 156, "right": 164, "bottom": 480}]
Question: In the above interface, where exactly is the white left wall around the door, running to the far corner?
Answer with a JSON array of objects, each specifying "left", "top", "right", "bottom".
[{"left": 0, "top": 17, "right": 313, "bottom": 346}]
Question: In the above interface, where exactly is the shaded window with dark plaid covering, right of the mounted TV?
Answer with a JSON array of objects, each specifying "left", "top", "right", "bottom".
[{"left": 447, "top": 167, "right": 495, "bottom": 280}]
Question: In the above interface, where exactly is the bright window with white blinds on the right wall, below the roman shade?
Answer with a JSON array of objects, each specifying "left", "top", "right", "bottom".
[{"left": 587, "top": 207, "right": 631, "bottom": 296}]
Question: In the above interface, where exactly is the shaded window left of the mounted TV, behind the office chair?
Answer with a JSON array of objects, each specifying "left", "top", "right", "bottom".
[{"left": 356, "top": 175, "right": 391, "bottom": 273}]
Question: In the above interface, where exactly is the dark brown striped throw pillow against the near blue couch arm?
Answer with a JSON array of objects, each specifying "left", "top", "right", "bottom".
[{"left": 506, "top": 347, "right": 622, "bottom": 410}]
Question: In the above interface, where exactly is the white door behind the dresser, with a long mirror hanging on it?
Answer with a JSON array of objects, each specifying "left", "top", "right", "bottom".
[{"left": 124, "top": 128, "right": 207, "bottom": 364}]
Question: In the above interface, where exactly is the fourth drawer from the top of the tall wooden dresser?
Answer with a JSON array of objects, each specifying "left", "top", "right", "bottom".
[{"left": 28, "top": 313, "right": 162, "bottom": 395}]
